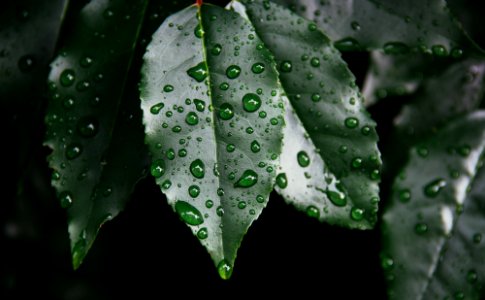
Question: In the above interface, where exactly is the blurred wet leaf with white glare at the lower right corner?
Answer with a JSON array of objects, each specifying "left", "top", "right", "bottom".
[{"left": 382, "top": 111, "right": 485, "bottom": 299}]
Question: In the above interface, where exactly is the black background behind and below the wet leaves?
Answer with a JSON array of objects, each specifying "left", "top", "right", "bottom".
[{"left": 0, "top": 0, "right": 481, "bottom": 300}]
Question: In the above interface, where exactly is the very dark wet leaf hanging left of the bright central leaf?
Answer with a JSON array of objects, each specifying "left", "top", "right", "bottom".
[{"left": 45, "top": 0, "right": 147, "bottom": 268}]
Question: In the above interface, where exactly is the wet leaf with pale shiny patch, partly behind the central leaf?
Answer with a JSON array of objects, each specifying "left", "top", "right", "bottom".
[{"left": 233, "top": 1, "right": 380, "bottom": 229}]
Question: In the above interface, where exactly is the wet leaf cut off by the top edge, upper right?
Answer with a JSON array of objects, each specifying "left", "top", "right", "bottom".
[{"left": 274, "top": 0, "right": 474, "bottom": 57}]
